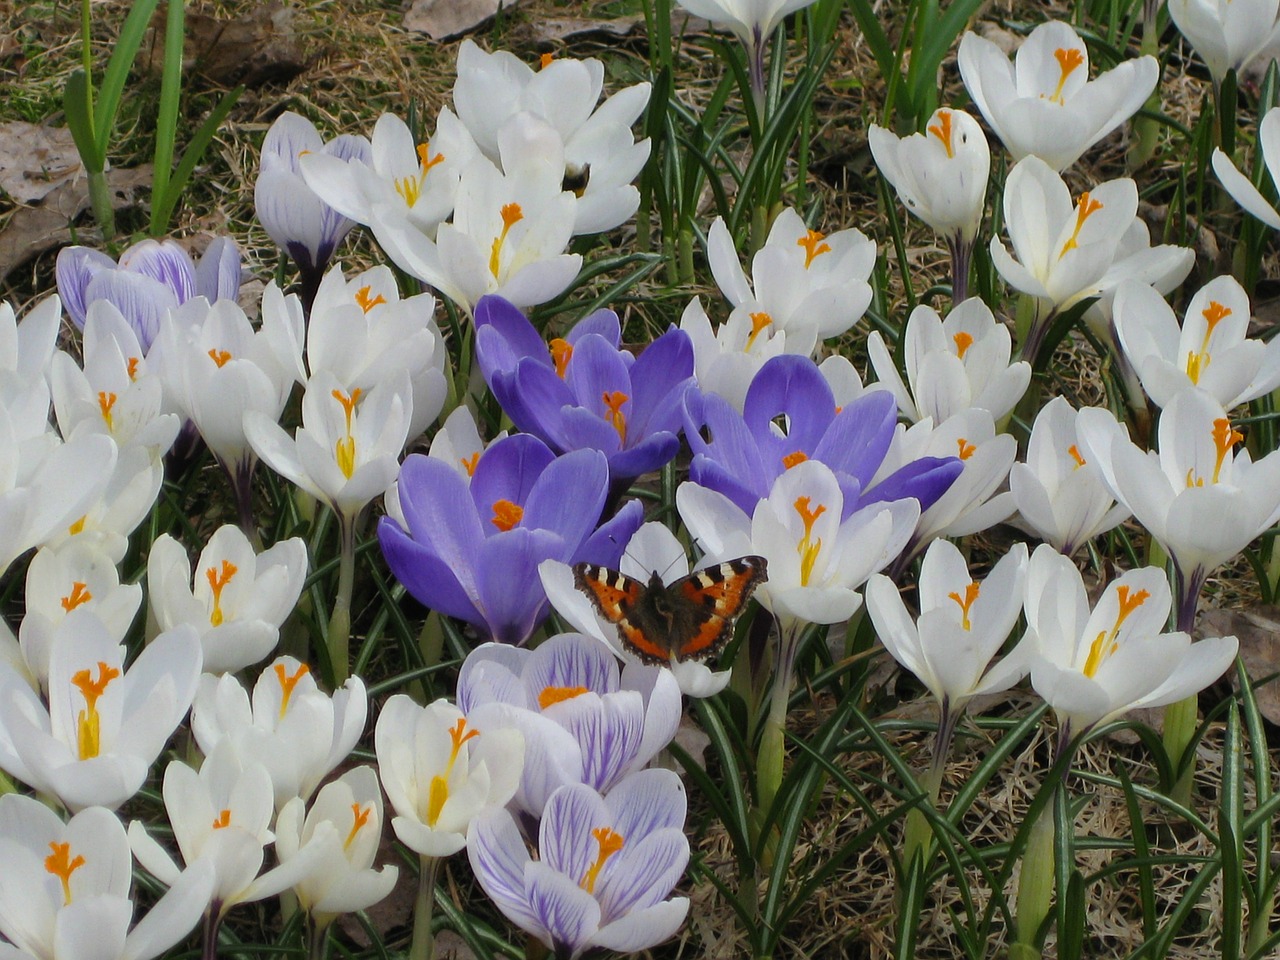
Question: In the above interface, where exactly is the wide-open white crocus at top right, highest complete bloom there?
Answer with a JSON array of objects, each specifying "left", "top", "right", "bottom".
[{"left": 956, "top": 20, "right": 1162, "bottom": 172}]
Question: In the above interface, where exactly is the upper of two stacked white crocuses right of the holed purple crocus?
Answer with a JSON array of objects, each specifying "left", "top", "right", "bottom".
[{"left": 867, "top": 297, "right": 1032, "bottom": 424}]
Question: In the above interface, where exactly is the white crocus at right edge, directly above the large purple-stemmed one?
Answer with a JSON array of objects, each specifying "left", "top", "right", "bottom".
[{"left": 1114, "top": 275, "right": 1280, "bottom": 410}]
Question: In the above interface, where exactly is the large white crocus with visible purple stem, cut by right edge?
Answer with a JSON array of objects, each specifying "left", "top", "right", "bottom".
[{"left": 1076, "top": 389, "right": 1280, "bottom": 631}]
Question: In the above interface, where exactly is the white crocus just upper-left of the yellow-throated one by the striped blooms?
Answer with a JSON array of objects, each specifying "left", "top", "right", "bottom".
[{"left": 191, "top": 657, "right": 369, "bottom": 808}]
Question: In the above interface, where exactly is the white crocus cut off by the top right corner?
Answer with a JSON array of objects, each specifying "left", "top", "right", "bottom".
[{"left": 1169, "top": 0, "right": 1280, "bottom": 87}]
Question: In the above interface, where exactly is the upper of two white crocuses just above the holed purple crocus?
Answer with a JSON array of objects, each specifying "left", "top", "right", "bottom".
[{"left": 707, "top": 207, "right": 876, "bottom": 353}]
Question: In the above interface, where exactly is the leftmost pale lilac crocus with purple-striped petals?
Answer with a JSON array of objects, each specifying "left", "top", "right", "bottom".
[{"left": 55, "top": 237, "right": 241, "bottom": 349}]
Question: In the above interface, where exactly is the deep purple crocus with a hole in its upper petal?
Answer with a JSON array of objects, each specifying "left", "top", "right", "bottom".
[{"left": 685, "top": 356, "right": 963, "bottom": 520}]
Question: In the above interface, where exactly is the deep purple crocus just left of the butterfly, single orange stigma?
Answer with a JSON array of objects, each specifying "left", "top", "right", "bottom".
[{"left": 378, "top": 434, "right": 644, "bottom": 644}]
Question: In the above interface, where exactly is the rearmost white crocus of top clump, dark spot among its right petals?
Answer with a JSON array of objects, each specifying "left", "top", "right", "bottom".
[{"left": 453, "top": 40, "right": 649, "bottom": 234}]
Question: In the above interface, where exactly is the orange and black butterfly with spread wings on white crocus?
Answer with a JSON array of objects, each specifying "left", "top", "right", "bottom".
[{"left": 573, "top": 557, "right": 768, "bottom": 666}]
